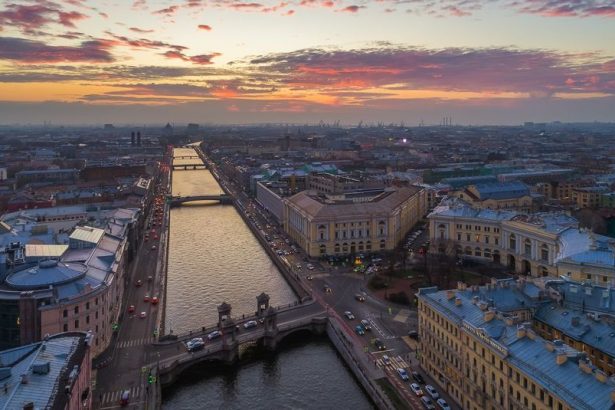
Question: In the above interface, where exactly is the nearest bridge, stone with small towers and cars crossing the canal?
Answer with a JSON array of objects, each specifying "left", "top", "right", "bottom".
[{"left": 147, "top": 293, "right": 329, "bottom": 386}]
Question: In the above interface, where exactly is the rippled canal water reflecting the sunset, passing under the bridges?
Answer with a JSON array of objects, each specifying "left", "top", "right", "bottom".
[{"left": 163, "top": 156, "right": 372, "bottom": 409}]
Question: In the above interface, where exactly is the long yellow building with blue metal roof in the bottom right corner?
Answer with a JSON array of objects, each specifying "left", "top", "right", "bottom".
[{"left": 417, "top": 281, "right": 615, "bottom": 410}]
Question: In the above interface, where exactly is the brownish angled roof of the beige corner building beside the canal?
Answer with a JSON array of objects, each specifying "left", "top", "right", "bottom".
[{"left": 287, "top": 187, "right": 420, "bottom": 219}]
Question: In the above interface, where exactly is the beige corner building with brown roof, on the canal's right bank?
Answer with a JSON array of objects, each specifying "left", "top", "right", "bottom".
[{"left": 284, "top": 187, "right": 426, "bottom": 257}]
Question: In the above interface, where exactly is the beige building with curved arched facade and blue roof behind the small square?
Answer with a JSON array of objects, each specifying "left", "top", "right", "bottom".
[{"left": 428, "top": 199, "right": 593, "bottom": 276}]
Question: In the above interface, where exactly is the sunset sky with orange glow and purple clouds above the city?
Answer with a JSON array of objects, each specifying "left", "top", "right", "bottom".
[{"left": 0, "top": 0, "right": 615, "bottom": 126}]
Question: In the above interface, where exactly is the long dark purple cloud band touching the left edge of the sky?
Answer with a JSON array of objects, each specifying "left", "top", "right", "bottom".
[{"left": 0, "top": 37, "right": 113, "bottom": 63}]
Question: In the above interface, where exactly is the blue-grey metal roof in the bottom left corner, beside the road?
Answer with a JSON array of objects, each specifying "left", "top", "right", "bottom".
[{"left": 0, "top": 332, "right": 89, "bottom": 410}]
